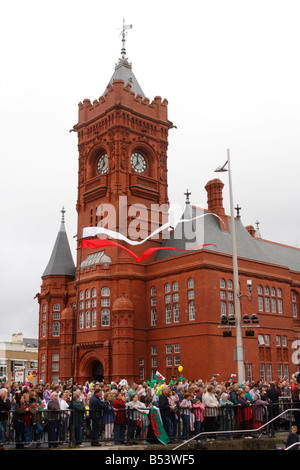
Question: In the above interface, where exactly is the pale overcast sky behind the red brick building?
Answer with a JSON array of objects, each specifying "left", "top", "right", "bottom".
[{"left": 0, "top": 0, "right": 300, "bottom": 341}]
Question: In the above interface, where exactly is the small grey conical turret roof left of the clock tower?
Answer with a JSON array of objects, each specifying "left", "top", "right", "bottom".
[{"left": 42, "top": 208, "right": 76, "bottom": 277}]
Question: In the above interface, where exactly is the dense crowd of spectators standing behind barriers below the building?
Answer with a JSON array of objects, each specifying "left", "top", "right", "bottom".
[{"left": 0, "top": 374, "right": 300, "bottom": 448}]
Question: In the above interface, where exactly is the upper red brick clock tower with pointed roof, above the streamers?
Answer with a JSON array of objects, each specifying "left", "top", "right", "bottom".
[{"left": 73, "top": 25, "right": 172, "bottom": 258}]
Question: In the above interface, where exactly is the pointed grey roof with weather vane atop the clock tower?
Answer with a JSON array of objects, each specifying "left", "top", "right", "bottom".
[{"left": 103, "top": 20, "right": 145, "bottom": 99}]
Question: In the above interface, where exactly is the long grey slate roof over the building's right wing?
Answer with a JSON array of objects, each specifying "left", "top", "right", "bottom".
[{"left": 156, "top": 204, "right": 300, "bottom": 272}]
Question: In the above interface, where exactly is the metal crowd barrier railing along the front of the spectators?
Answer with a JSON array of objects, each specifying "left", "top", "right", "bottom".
[{"left": 0, "top": 399, "right": 300, "bottom": 450}]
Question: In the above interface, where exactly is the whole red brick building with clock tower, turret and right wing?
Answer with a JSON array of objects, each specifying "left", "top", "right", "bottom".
[{"left": 38, "top": 43, "right": 300, "bottom": 382}]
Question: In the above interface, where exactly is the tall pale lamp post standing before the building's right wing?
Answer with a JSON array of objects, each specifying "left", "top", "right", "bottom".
[{"left": 215, "top": 149, "right": 245, "bottom": 384}]
